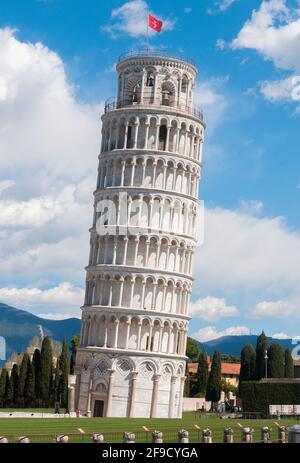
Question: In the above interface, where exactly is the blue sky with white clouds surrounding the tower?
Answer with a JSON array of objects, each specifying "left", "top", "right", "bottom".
[{"left": 0, "top": 0, "right": 300, "bottom": 340}]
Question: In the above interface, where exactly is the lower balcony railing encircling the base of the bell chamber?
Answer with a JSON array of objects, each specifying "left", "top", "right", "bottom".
[{"left": 104, "top": 98, "right": 204, "bottom": 122}]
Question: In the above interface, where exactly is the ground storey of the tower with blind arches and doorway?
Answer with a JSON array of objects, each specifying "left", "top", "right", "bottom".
[{"left": 74, "top": 349, "right": 185, "bottom": 418}]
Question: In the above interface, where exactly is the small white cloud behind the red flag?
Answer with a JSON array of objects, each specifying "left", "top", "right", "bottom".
[{"left": 102, "top": 0, "right": 175, "bottom": 39}]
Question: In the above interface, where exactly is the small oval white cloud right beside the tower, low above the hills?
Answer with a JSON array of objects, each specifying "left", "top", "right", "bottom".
[{"left": 190, "top": 296, "right": 239, "bottom": 322}]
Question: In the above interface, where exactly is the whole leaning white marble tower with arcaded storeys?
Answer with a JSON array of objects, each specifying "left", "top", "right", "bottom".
[{"left": 71, "top": 52, "right": 205, "bottom": 418}]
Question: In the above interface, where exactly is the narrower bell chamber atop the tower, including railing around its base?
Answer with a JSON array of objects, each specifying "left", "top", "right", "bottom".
[{"left": 105, "top": 52, "right": 204, "bottom": 126}]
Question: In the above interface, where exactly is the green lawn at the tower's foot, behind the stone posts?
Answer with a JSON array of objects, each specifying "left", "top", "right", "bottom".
[{"left": 0, "top": 413, "right": 296, "bottom": 443}]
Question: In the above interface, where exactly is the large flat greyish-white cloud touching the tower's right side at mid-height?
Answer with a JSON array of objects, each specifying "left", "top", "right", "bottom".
[{"left": 194, "top": 208, "right": 300, "bottom": 304}]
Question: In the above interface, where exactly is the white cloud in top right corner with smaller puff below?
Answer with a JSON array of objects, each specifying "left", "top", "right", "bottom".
[{"left": 231, "top": 0, "right": 300, "bottom": 106}]
